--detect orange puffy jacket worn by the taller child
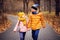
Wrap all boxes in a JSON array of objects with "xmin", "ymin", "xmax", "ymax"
[{"xmin": 28, "ymin": 13, "xmax": 45, "ymax": 30}]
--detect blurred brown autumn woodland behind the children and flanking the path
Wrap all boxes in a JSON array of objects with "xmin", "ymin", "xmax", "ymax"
[{"xmin": 0, "ymin": 0, "xmax": 60, "ymax": 33}]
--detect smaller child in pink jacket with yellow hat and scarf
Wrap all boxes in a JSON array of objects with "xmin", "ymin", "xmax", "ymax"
[{"xmin": 14, "ymin": 12, "xmax": 27, "ymax": 40}]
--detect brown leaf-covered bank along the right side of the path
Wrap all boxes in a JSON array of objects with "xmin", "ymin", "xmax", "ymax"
[{"xmin": 44, "ymin": 12, "xmax": 60, "ymax": 34}]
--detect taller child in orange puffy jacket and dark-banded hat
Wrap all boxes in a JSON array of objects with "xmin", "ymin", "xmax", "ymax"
[{"xmin": 28, "ymin": 4, "xmax": 45, "ymax": 40}]
